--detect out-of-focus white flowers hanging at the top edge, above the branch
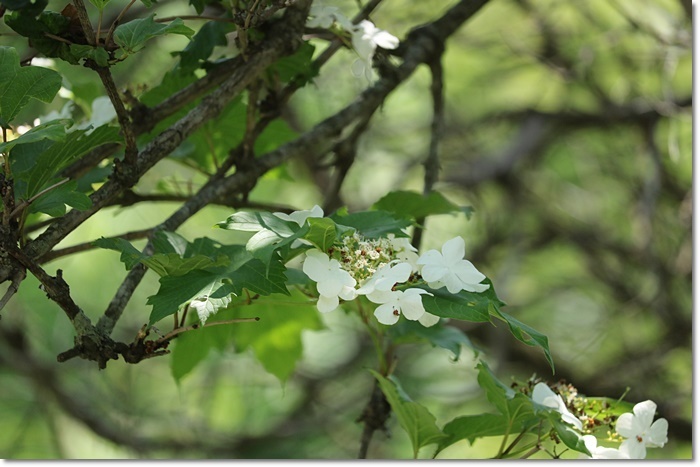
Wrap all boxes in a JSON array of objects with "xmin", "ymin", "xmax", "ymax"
[{"xmin": 306, "ymin": 0, "xmax": 399, "ymax": 81}]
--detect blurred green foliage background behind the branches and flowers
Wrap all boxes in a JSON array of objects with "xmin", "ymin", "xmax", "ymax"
[{"xmin": 0, "ymin": 0, "xmax": 692, "ymax": 459}]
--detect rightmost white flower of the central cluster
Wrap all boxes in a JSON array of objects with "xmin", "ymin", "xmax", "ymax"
[{"xmin": 417, "ymin": 237, "xmax": 489, "ymax": 293}]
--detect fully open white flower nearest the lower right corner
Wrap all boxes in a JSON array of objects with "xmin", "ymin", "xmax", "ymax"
[{"xmin": 615, "ymin": 401, "xmax": 668, "ymax": 459}]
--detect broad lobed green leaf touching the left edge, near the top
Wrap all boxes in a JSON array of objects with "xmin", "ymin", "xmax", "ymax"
[{"xmin": 0, "ymin": 46, "xmax": 62, "ymax": 124}]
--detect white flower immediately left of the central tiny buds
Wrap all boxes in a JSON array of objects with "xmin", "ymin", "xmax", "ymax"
[{"xmin": 302, "ymin": 250, "xmax": 357, "ymax": 313}]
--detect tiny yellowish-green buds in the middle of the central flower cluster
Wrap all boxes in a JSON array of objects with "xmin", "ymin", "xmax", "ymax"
[{"xmin": 328, "ymin": 233, "xmax": 394, "ymax": 283}]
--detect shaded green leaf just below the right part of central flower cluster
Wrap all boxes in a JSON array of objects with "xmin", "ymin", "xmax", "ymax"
[{"xmin": 389, "ymin": 320, "xmax": 480, "ymax": 361}]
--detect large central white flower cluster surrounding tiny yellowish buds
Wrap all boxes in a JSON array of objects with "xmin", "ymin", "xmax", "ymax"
[{"xmin": 275, "ymin": 206, "xmax": 489, "ymax": 326}]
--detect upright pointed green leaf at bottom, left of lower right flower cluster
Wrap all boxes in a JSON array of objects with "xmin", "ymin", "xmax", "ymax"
[{"xmin": 369, "ymin": 370, "xmax": 445, "ymax": 459}]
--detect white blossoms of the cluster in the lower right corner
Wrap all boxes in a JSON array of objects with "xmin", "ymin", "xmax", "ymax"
[{"xmin": 532, "ymin": 383, "xmax": 668, "ymax": 459}]
